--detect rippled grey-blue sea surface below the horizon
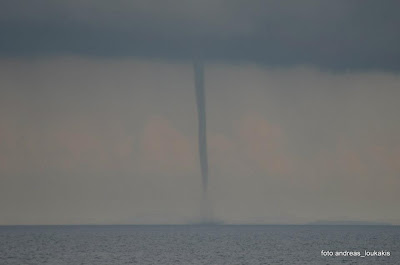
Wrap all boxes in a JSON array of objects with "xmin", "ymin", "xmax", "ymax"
[{"xmin": 0, "ymin": 225, "xmax": 400, "ymax": 265}]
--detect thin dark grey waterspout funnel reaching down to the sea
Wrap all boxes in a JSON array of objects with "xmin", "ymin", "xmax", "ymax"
[{"xmin": 193, "ymin": 61, "xmax": 210, "ymax": 221}]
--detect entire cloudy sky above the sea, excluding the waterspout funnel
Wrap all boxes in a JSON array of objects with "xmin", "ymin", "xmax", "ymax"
[{"xmin": 0, "ymin": 0, "xmax": 400, "ymax": 224}]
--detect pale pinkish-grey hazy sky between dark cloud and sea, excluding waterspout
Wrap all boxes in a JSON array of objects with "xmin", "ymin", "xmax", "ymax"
[{"xmin": 0, "ymin": 57, "xmax": 400, "ymax": 224}]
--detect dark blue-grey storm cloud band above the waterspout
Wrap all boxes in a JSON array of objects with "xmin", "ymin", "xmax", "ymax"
[{"xmin": 0, "ymin": 0, "xmax": 400, "ymax": 70}]
